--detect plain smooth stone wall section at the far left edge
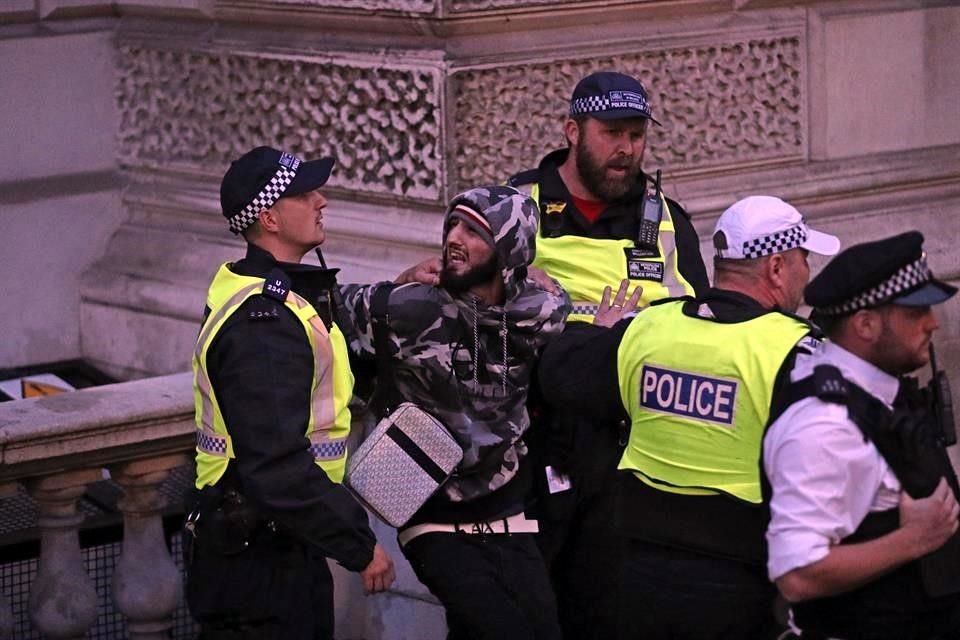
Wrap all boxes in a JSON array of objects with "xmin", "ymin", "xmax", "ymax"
[{"xmin": 0, "ymin": 26, "xmax": 124, "ymax": 368}]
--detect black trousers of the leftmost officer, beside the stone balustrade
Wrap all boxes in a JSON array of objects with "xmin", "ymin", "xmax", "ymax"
[{"xmin": 185, "ymin": 540, "xmax": 334, "ymax": 640}]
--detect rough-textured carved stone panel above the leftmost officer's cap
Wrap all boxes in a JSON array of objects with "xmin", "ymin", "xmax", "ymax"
[{"xmin": 117, "ymin": 43, "xmax": 443, "ymax": 200}]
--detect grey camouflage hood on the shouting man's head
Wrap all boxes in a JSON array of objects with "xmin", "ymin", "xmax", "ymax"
[{"xmin": 442, "ymin": 186, "xmax": 539, "ymax": 299}]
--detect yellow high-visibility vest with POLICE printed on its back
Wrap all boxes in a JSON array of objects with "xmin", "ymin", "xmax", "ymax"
[{"xmin": 617, "ymin": 301, "xmax": 809, "ymax": 504}]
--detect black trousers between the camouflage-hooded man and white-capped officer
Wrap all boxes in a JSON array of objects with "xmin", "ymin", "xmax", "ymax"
[{"xmin": 536, "ymin": 422, "xmax": 624, "ymax": 640}]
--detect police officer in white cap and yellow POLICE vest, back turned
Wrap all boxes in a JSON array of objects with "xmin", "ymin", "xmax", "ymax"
[{"xmin": 540, "ymin": 196, "xmax": 839, "ymax": 640}]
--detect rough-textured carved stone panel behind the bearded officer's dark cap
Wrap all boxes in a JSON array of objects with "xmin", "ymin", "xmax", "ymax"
[{"xmin": 453, "ymin": 35, "xmax": 806, "ymax": 188}]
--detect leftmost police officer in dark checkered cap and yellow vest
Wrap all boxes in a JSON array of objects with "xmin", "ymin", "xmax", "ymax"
[{"xmin": 187, "ymin": 147, "xmax": 394, "ymax": 640}]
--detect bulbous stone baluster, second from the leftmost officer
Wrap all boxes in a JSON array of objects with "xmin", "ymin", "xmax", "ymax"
[{"xmin": 26, "ymin": 469, "xmax": 101, "ymax": 639}]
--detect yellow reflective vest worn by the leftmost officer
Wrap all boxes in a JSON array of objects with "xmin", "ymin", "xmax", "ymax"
[{"xmin": 193, "ymin": 265, "xmax": 353, "ymax": 488}]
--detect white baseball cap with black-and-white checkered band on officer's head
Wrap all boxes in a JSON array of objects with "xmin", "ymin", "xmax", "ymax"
[{"xmin": 713, "ymin": 196, "xmax": 840, "ymax": 260}]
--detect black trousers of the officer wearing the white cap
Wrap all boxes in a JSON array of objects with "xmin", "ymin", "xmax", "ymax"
[{"xmin": 617, "ymin": 540, "xmax": 779, "ymax": 640}]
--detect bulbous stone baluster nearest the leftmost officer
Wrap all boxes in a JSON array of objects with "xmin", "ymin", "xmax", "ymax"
[{"xmin": 110, "ymin": 454, "xmax": 187, "ymax": 640}]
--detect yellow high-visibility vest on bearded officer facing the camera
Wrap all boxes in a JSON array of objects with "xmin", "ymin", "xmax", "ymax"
[{"xmin": 530, "ymin": 184, "xmax": 694, "ymax": 322}]
